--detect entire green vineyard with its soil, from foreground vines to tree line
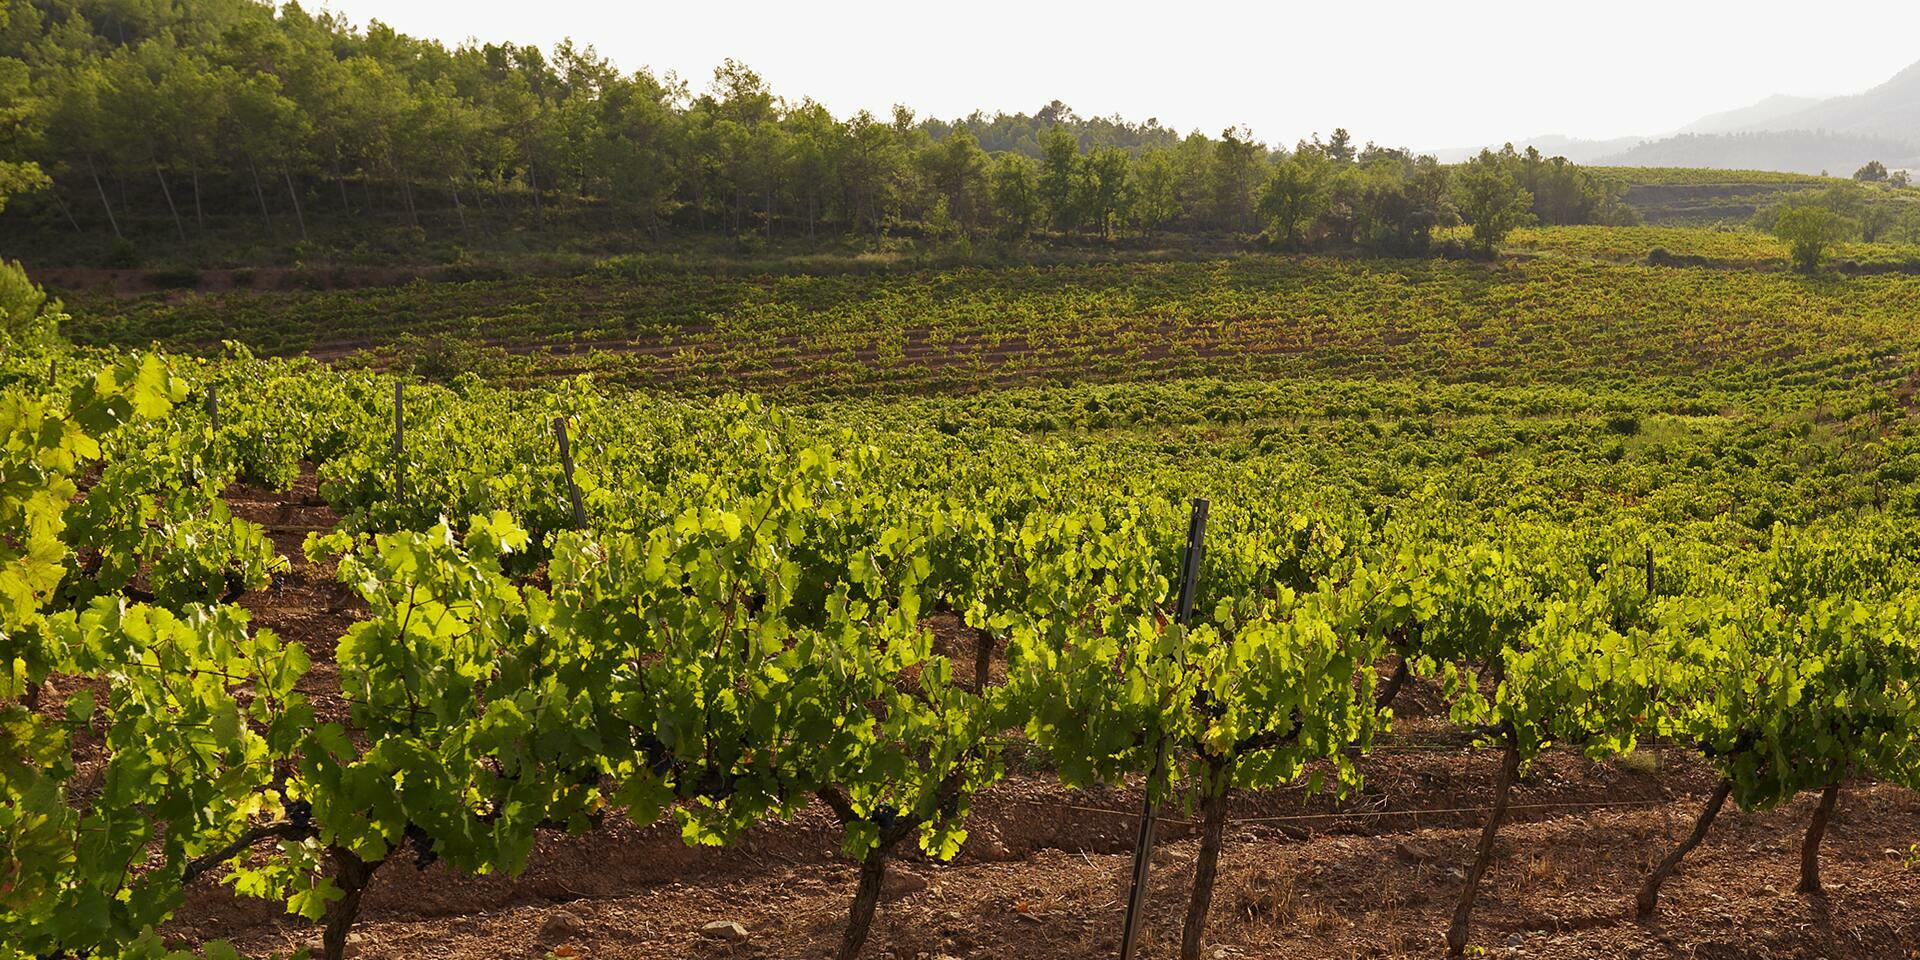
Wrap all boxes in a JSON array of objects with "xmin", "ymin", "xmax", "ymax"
[{"xmin": 11, "ymin": 228, "xmax": 1920, "ymax": 960}]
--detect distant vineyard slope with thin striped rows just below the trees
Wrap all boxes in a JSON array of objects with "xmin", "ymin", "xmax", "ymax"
[{"xmin": 52, "ymin": 251, "xmax": 1920, "ymax": 399}]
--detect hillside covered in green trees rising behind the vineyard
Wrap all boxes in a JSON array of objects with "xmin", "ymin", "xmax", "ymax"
[{"xmin": 0, "ymin": 0, "xmax": 1626, "ymax": 265}]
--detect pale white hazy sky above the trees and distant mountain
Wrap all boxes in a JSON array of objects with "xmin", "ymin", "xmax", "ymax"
[{"xmin": 326, "ymin": 0, "xmax": 1920, "ymax": 148}]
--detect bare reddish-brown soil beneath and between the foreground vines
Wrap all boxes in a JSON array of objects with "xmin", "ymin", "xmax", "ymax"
[{"xmin": 157, "ymin": 483, "xmax": 1920, "ymax": 960}]
